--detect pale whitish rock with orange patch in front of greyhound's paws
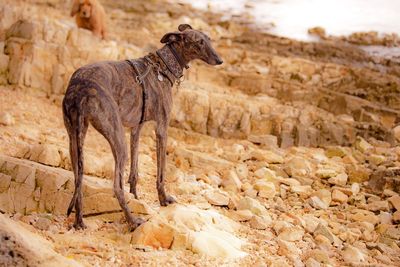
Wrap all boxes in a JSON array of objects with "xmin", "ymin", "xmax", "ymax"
[{"xmin": 131, "ymin": 205, "xmax": 246, "ymax": 258}]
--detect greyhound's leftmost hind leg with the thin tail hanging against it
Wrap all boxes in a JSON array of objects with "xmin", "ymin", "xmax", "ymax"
[{"xmin": 64, "ymin": 105, "xmax": 88, "ymax": 229}]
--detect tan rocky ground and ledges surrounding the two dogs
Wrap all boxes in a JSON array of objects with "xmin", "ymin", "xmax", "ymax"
[{"xmin": 0, "ymin": 0, "xmax": 400, "ymax": 267}]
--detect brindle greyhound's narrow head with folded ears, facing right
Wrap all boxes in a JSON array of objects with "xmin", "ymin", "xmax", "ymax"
[{"xmin": 161, "ymin": 24, "xmax": 223, "ymax": 65}]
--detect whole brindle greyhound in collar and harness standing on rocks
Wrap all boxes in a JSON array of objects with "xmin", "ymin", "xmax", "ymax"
[{"xmin": 63, "ymin": 24, "xmax": 223, "ymax": 230}]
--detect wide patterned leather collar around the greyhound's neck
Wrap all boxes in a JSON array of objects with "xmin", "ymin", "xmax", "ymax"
[{"xmin": 156, "ymin": 44, "xmax": 189, "ymax": 79}]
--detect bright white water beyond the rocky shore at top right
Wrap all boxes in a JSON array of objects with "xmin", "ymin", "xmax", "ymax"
[{"xmin": 180, "ymin": 0, "xmax": 400, "ymax": 41}]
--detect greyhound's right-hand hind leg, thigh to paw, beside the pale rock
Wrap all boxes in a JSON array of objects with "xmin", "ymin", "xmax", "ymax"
[{"xmin": 90, "ymin": 98, "xmax": 144, "ymax": 230}]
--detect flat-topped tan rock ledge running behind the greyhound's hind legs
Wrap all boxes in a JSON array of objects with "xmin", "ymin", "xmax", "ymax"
[{"xmin": 0, "ymin": 156, "xmax": 154, "ymax": 215}]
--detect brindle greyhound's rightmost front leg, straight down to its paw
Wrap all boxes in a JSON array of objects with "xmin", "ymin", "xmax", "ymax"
[{"xmin": 156, "ymin": 122, "xmax": 176, "ymax": 206}]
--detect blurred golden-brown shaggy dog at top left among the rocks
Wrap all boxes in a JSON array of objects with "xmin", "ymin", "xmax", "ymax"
[{"xmin": 71, "ymin": 0, "xmax": 106, "ymax": 39}]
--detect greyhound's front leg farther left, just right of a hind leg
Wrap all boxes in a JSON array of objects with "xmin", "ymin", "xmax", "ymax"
[{"xmin": 129, "ymin": 124, "xmax": 143, "ymax": 199}]
